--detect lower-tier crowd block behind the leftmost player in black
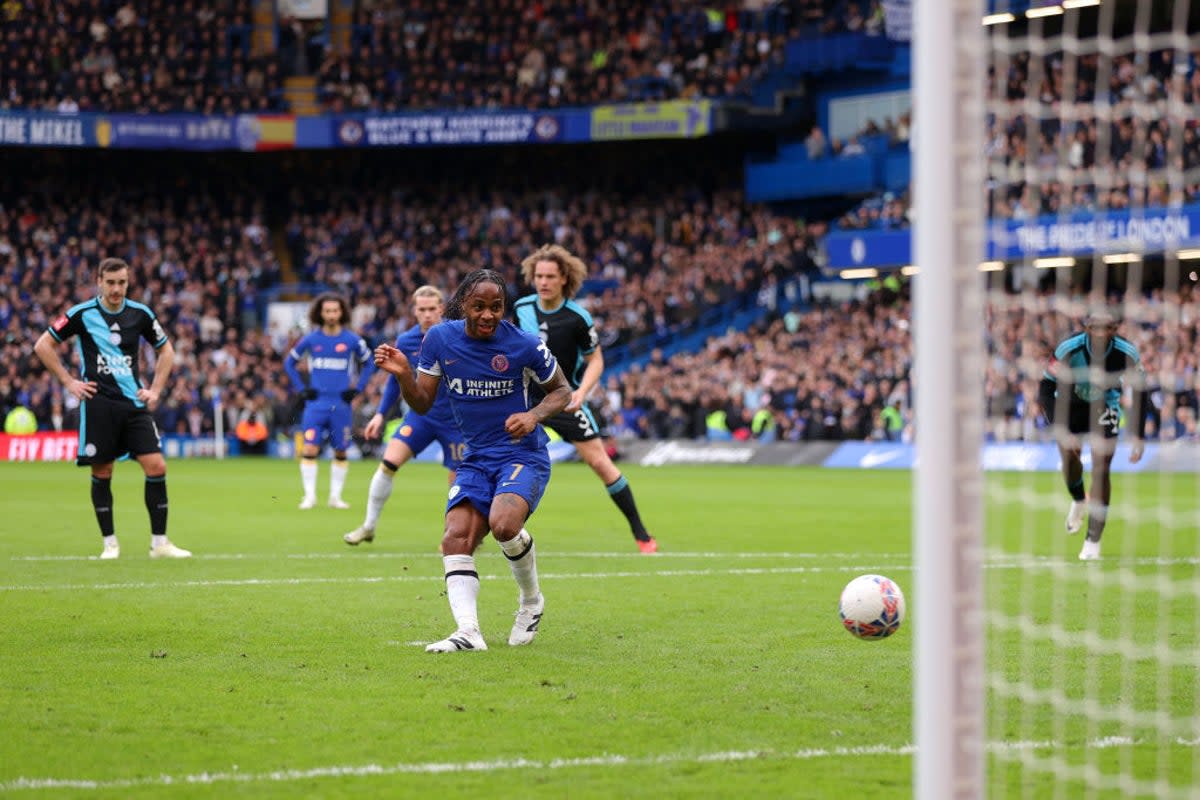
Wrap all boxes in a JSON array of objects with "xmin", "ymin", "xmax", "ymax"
[{"xmin": 0, "ymin": 152, "xmax": 286, "ymax": 434}]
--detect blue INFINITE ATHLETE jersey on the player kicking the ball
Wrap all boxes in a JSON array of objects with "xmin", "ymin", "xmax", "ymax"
[{"xmin": 416, "ymin": 319, "xmax": 558, "ymax": 461}]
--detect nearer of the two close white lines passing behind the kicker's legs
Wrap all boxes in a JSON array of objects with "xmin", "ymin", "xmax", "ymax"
[{"xmin": 0, "ymin": 557, "xmax": 1200, "ymax": 593}]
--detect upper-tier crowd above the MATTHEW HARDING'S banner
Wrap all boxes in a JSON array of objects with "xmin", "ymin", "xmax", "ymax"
[{"xmin": 0, "ymin": 0, "xmax": 902, "ymax": 114}]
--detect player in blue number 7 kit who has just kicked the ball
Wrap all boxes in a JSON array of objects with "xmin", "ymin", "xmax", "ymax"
[{"xmin": 374, "ymin": 270, "xmax": 571, "ymax": 652}]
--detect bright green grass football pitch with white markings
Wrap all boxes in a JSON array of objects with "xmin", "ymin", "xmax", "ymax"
[{"xmin": 0, "ymin": 459, "xmax": 1200, "ymax": 798}]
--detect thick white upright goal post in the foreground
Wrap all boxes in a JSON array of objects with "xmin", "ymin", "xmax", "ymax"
[{"xmin": 912, "ymin": 0, "xmax": 984, "ymax": 800}]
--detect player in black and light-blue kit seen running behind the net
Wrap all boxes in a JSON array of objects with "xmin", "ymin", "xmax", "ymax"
[{"xmin": 1038, "ymin": 309, "xmax": 1150, "ymax": 561}]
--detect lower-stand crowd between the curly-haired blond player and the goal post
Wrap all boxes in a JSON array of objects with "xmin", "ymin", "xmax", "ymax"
[{"xmin": 599, "ymin": 280, "xmax": 912, "ymax": 441}]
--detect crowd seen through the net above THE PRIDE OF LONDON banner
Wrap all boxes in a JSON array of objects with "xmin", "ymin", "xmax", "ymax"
[{"xmin": 986, "ymin": 49, "xmax": 1200, "ymax": 219}]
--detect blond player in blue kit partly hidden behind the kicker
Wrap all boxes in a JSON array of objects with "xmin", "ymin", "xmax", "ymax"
[{"xmin": 342, "ymin": 285, "xmax": 466, "ymax": 545}]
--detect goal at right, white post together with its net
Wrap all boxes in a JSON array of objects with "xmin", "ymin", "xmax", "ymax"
[{"xmin": 913, "ymin": 0, "xmax": 1200, "ymax": 798}]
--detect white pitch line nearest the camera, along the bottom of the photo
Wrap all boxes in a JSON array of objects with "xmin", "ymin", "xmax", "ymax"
[{"xmin": 0, "ymin": 736, "xmax": 1196, "ymax": 793}]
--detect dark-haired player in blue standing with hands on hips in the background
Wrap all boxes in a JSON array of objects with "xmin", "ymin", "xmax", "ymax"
[{"xmin": 283, "ymin": 294, "xmax": 374, "ymax": 510}]
